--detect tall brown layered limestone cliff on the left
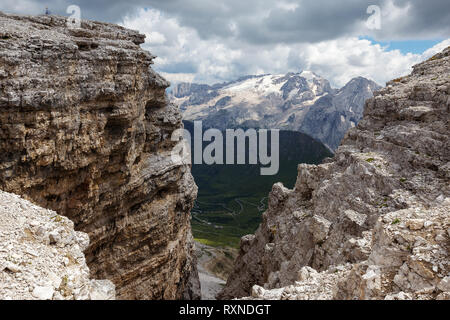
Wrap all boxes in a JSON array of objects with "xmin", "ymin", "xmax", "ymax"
[{"xmin": 0, "ymin": 14, "xmax": 199, "ymax": 299}]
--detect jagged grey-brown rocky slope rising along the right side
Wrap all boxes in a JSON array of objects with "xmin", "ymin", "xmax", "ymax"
[{"xmin": 220, "ymin": 48, "xmax": 450, "ymax": 299}]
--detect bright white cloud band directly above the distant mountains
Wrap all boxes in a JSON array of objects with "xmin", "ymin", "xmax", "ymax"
[{"xmin": 122, "ymin": 7, "xmax": 450, "ymax": 87}]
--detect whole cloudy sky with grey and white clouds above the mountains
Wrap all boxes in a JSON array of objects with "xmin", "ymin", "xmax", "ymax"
[{"xmin": 0, "ymin": 0, "xmax": 450, "ymax": 87}]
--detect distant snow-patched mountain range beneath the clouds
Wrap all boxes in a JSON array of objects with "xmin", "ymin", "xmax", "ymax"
[{"xmin": 169, "ymin": 71, "xmax": 381, "ymax": 151}]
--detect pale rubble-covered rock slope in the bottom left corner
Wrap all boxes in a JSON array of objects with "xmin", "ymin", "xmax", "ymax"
[{"xmin": 0, "ymin": 191, "xmax": 115, "ymax": 300}]
